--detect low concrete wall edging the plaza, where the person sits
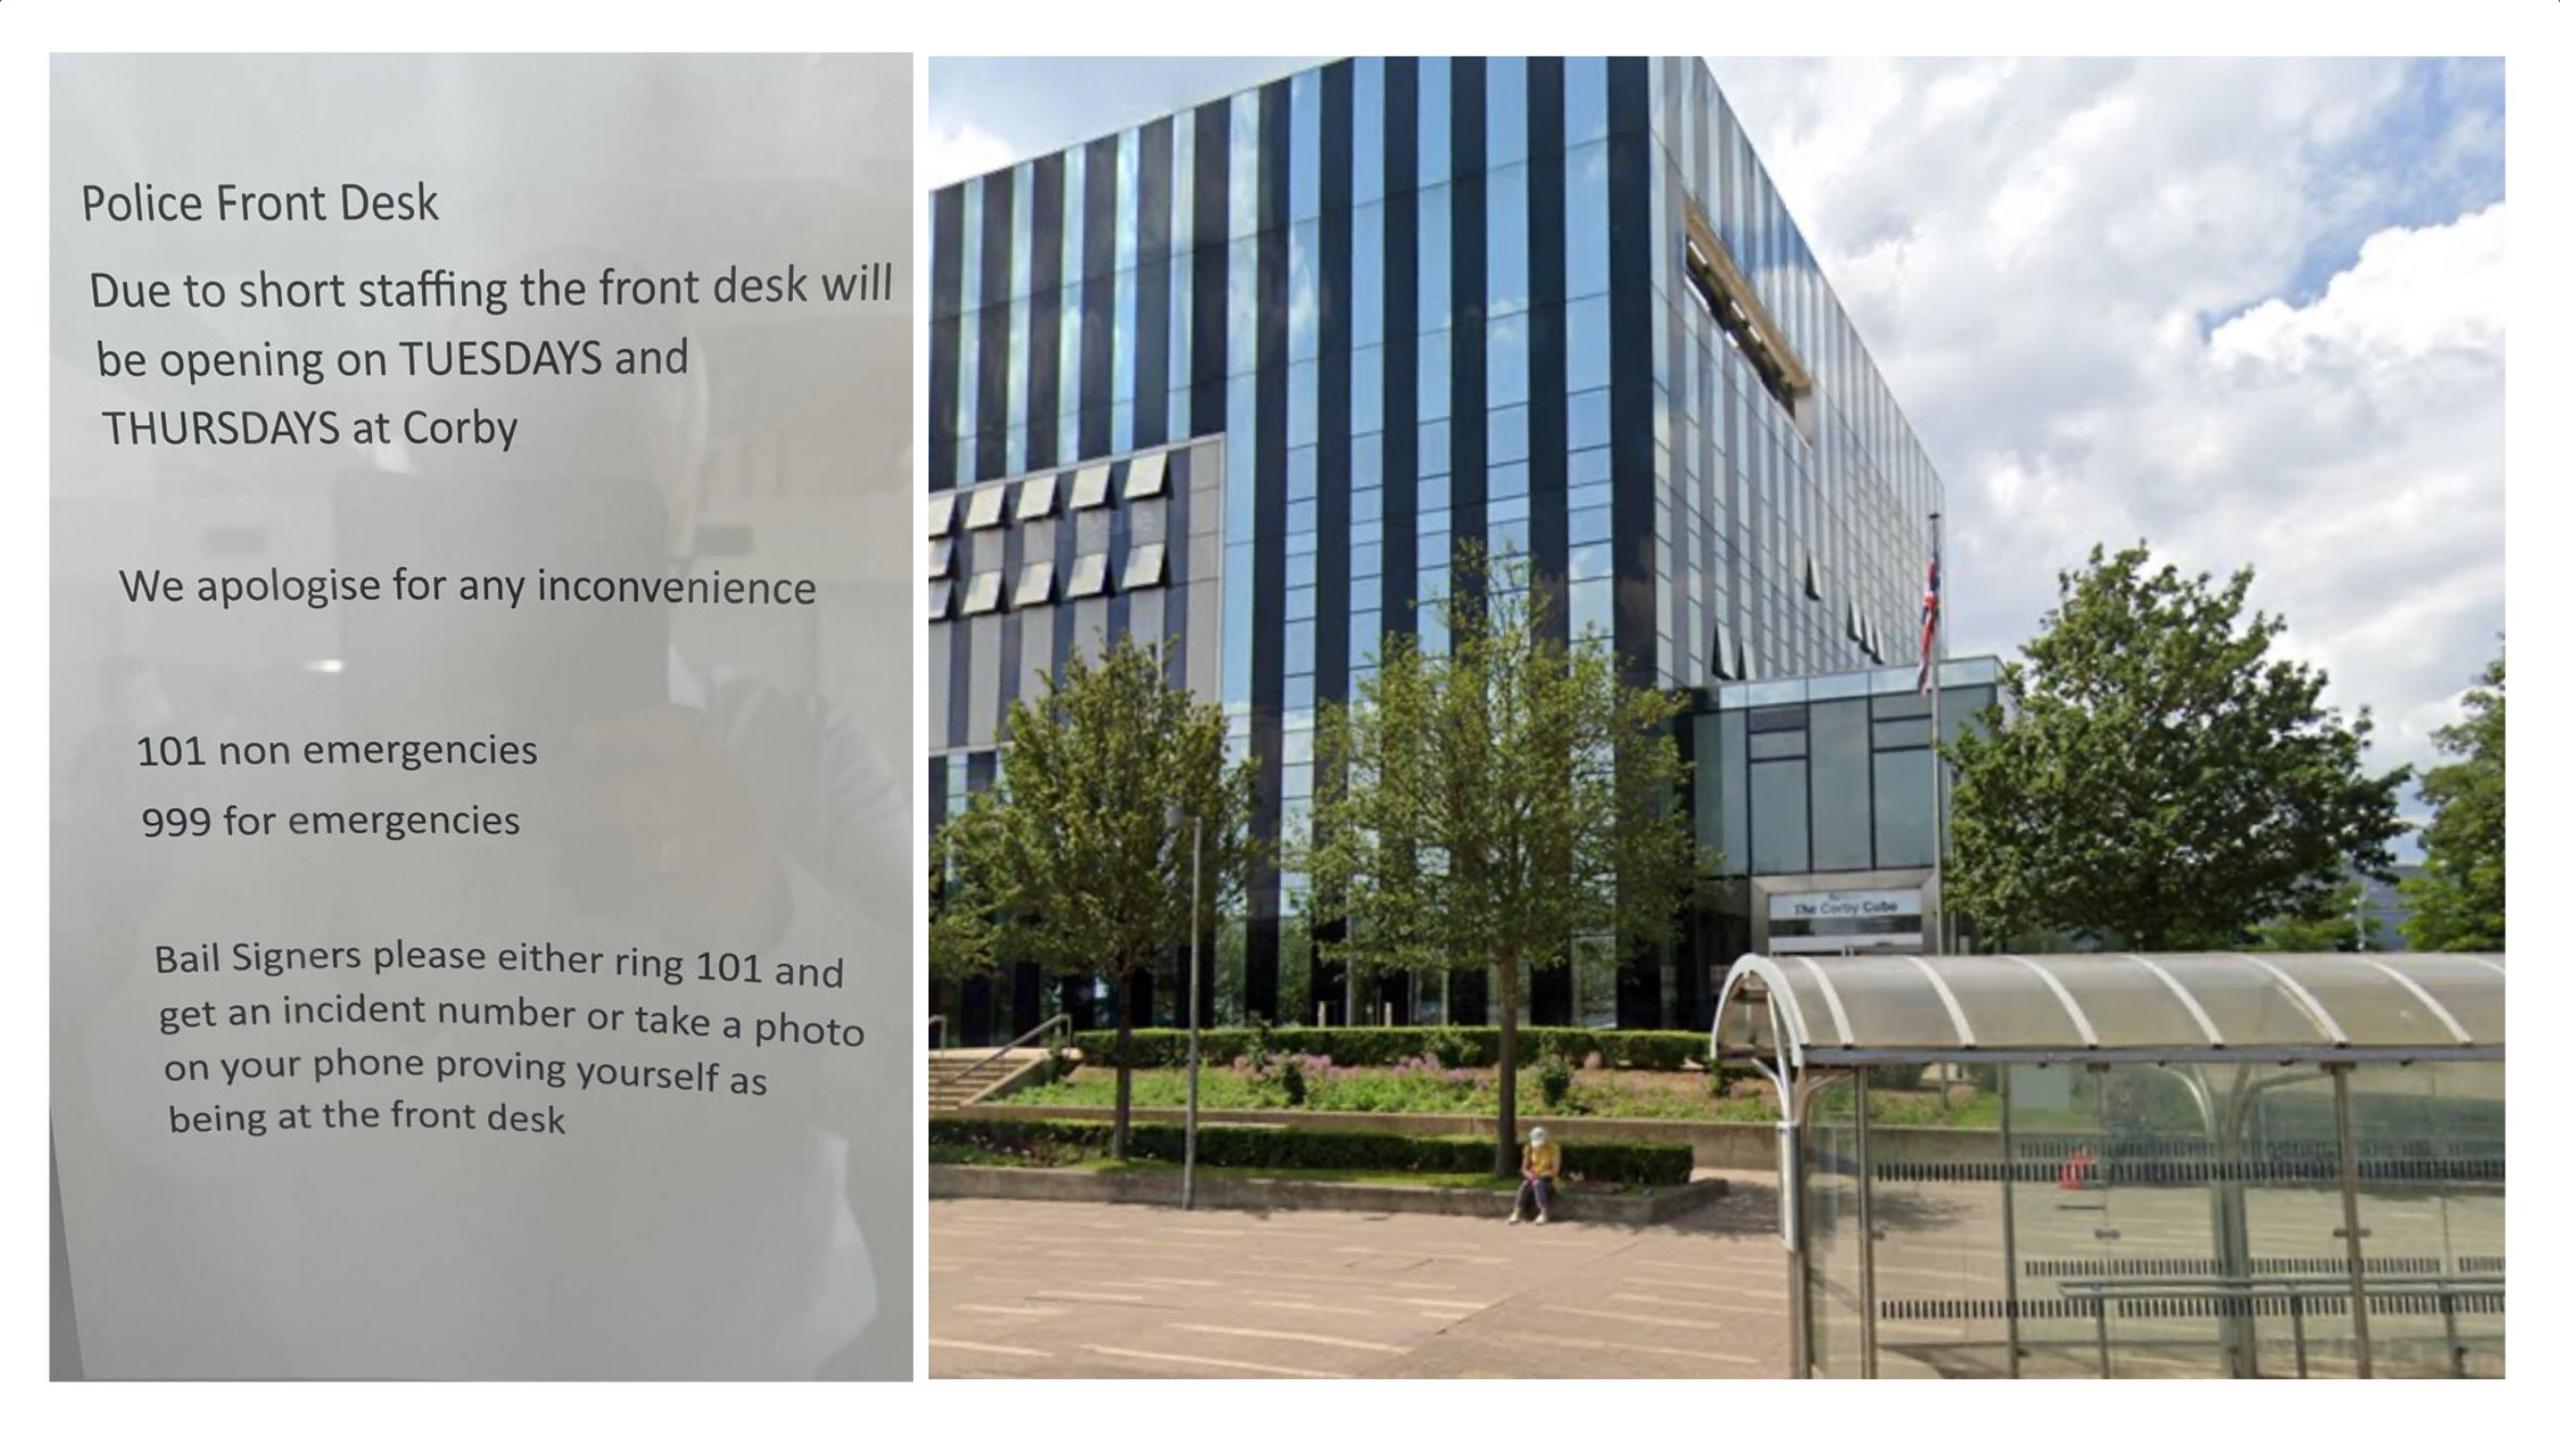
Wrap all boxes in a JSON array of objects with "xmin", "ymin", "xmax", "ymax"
[{"xmin": 927, "ymin": 1165, "xmax": 1725, "ymax": 1227}]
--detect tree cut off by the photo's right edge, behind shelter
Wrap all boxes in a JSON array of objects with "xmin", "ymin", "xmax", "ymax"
[{"xmin": 2401, "ymin": 656, "xmax": 2506, "ymax": 953}]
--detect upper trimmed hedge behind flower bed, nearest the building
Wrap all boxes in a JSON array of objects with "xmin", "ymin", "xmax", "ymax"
[{"xmin": 1075, "ymin": 1027, "xmax": 1713, "ymax": 1070}]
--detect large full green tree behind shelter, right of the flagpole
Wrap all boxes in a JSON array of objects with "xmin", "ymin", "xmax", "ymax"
[{"xmin": 1948, "ymin": 545, "xmax": 2409, "ymax": 950}]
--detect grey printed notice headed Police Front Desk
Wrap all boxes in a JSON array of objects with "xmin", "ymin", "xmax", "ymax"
[{"xmin": 49, "ymin": 56, "xmax": 914, "ymax": 1378}]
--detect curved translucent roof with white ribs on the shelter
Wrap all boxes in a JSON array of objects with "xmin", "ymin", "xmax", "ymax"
[{"xmin": 1715, "ymin": 953, "xmax": 2506, "ymax": 1065}]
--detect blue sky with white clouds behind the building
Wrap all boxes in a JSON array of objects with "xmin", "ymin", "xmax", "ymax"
[{"xmin": 924, "ymin": 56, "xmax": 2506, "ymax": 829}]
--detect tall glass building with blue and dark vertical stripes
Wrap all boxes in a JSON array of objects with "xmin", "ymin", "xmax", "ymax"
[{"xmin": 927, "ymin": 59, "xmax": 1940, "ymax": 1040}]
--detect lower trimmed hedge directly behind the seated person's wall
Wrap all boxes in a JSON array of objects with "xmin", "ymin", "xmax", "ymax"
[{"xmin": 929, "ymin": 1117, "xmax": 1692, "ymax": 1186}]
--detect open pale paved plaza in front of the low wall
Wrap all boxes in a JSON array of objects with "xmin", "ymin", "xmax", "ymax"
[{"xmin": 929, "ymin": 1173, "xmax": 1787, "ymax": 1378}]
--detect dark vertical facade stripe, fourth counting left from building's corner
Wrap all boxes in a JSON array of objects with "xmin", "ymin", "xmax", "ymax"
[{"xmin": 1377, "ymin": 59, "xmax": 1421, "ymax": 635}]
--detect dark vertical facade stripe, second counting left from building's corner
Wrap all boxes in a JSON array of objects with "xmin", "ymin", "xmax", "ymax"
[{"xmin": 1528, "ymin": 59, "xmax": 1574, "ymax": 1027}]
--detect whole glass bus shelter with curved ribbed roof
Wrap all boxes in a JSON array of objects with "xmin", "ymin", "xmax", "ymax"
[{"xmin": 1715, "ymin": 953, "xmax": 2506, "ymax": 1378}]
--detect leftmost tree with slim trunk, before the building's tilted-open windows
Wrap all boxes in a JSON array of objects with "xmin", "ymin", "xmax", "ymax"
[{"xmin": 932, "ymin": 640, "xmax": 1252, "ymax": 1158}]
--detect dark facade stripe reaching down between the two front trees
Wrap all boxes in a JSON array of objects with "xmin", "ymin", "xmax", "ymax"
[{"xmin": 1244, "ymin": 79, "xmax": 1288, "ymax": 1022}]
